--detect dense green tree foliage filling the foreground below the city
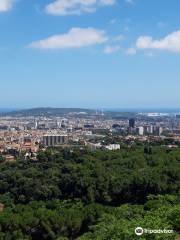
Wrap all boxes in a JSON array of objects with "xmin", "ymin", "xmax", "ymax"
[{"xmin": 0, "ymin": 146, "xmax": 180, "ymax": 240}]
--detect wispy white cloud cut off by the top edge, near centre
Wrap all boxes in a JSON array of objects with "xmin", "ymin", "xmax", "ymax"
[{"xmin": 45, "ymin": 0, "xmax": 116, "ymax": 16}]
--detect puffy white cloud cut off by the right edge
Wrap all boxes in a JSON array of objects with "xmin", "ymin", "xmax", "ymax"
[{"xmin": 136, "ymin": 30, "xmax": 180, "ymax": 53}]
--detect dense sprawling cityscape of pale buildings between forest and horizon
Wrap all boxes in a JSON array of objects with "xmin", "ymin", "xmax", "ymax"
[{"xmin": 0, "ymin": 109, "xmax": 180, "ymax": 161}]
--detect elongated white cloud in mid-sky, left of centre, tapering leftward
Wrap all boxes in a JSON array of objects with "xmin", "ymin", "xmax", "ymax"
[{"xmin": 29, "ymin": 28, "xmax": 108, "ymax": 49}]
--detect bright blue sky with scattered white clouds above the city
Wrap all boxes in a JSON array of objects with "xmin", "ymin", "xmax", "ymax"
[{"xmin": 0, "ymin": 0, "xmax": 180, "ymax": 108}]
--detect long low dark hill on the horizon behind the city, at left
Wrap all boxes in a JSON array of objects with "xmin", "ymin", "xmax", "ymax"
[{"xmin": 1, "ymin": 107, "xmax": 95, "ymax": 117}]
